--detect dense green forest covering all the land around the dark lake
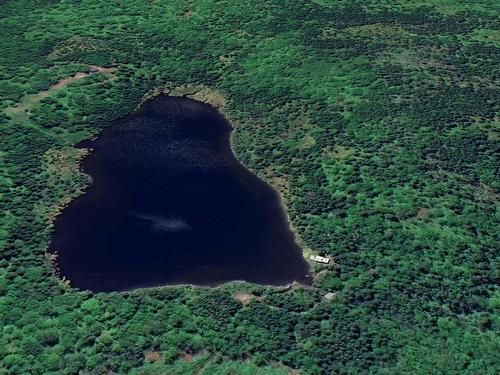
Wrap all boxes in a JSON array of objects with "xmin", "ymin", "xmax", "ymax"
[{"xmin": 0, "ymin": 0, "xmax": 500, "ymax": 375}]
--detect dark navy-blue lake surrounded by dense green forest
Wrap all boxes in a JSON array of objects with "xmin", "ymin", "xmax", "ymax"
[{"xmin": 50, "ymin": 95, "xmax": 312, "ymax": 291}]
